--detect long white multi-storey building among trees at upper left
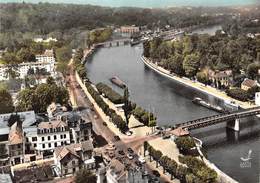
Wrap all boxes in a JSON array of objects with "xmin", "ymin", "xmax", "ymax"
[{"xmin": 0, "ymin": 50, "xmax": 55, "ymax": 80}]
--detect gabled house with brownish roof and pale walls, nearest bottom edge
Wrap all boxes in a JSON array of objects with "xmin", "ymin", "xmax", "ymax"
[{"xmin": 54, "ymin": 140, "xmax": 95, "ymax": 176}]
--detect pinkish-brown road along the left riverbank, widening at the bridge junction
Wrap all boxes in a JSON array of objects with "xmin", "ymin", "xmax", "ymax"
[{"xmin": 67, "ymin": 64, "xmax": 175, "ymax": 182}]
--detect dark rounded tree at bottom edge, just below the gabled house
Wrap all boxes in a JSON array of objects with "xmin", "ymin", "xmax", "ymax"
[{"xmin": 75, "ymin": 168, "xmax": 97, "ymax": 183}]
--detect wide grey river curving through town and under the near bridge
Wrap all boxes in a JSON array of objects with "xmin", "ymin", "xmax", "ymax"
[{"xmin": 86, "ymin": 41, "xmax": 260, "ymax": 183}]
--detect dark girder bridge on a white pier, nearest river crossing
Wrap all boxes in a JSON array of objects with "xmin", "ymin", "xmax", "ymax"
[{"xmin": 175, "ymin": 107, "xmax": 260, "ymax": 131}]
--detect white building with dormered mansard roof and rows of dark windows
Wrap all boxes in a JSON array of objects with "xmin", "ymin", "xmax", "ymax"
[{"xmin": 26, "ymin": 121, "xmax": 70, "ymax": 152}]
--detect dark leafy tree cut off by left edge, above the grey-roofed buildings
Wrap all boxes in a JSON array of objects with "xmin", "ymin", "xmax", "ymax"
[{"xmin": 0, "ymin": 89, "xmax": 14, "ymax": 114}]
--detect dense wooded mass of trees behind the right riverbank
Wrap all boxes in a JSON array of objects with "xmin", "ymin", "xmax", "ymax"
[{"xmin": 144, "ymin": 31, "xmax": 260, "ymax": 79}]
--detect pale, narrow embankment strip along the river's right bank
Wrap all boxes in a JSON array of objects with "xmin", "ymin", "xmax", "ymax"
[{"xmin": 141, "ymin": 56, "xmax": 256, "ymax": 109}]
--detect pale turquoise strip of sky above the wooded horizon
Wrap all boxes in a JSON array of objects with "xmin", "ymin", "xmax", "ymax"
[{"xmin": 0, "ymin": 0, "xmax": 260, "ymax": 8}]
